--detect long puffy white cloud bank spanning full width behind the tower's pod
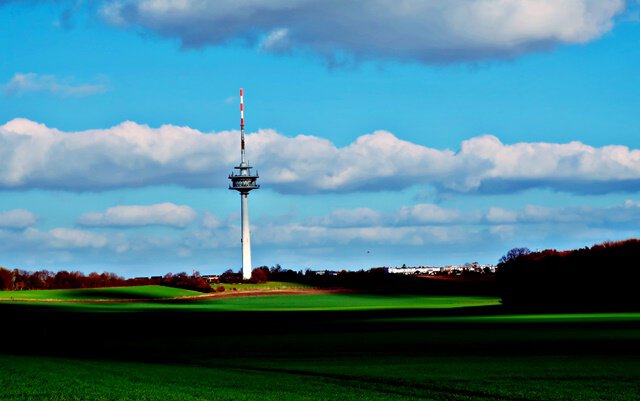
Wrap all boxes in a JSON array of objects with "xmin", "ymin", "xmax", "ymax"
[{"xmin": 0, "ymin": 119, "xmax": 640, "ymax": 195}]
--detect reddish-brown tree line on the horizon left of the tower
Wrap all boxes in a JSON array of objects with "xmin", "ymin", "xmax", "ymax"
[{"xmin": 0, "ymin": 267, "xmax": 211, "ymax": 292}]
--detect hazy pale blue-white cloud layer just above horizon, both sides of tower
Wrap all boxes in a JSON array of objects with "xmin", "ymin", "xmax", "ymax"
[{"xmin": 0, "ymin": 199, "xmax": 640, "ymax": 274}]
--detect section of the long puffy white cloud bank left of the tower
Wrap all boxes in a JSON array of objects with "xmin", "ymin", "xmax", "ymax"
[{"xmin": 0, "ymin": 119, "xmax": 239, "ymax": 190}]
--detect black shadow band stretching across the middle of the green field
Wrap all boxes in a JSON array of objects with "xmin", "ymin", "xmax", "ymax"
[{"xmin": 0, "ymin": 304, "xmax": 640, "ymax": 363}]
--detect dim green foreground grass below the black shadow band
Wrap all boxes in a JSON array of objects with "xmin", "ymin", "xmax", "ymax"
[{"xmin": 0, "ymin": 355, "xmax": 640, "ymax": 401}]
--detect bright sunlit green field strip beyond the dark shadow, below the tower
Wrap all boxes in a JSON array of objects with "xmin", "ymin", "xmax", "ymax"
[{"xmin": 0, "ymin": 283, "xmax": 500, "ymax": 311}]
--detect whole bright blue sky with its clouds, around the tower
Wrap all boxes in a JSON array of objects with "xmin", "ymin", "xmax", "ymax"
[{"xmin": 0, "ymin": 0, "xmax": 640, "ymax": 276}]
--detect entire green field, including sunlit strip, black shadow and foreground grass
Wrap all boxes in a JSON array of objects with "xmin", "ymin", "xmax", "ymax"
[{"xmin": 0, "ymin": 282, "xmax": 640, "ymax": 401}]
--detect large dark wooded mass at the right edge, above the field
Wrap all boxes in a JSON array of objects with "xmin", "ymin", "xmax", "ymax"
[{"xmin": 496, "ymin": 239, "xmax": 640, "ymax": 310}]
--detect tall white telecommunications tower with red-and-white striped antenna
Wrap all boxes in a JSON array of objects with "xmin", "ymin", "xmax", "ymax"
[{"xmin": 229, "ymin": 88, "xmax": 260, "ymax": 280}]
